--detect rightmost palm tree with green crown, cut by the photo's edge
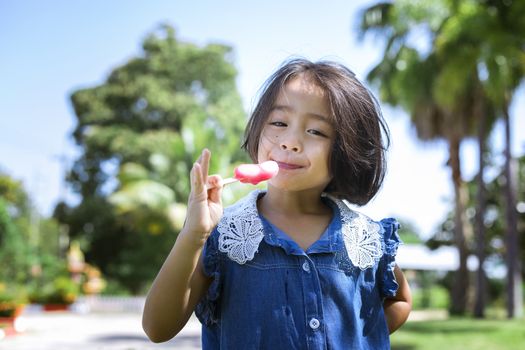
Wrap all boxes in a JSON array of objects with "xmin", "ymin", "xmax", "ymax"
[{"xmin": 480, "ymin": 0, "xmax": 525, "ymax": 318}]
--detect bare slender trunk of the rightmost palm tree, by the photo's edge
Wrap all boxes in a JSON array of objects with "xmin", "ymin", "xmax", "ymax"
[{"xmin": 503, "ymin": 106, "xmax": 523, "ymax": 318}]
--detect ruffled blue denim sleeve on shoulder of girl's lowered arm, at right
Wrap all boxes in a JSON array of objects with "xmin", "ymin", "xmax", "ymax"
[{"xmin": 380, "ymin": 218, "xmax": 402, "ymax": 298}]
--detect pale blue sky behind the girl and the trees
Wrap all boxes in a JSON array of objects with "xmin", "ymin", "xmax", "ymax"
[{"xmin": 0, "ymin": 0, "xmax": 525, "ymax": 236}]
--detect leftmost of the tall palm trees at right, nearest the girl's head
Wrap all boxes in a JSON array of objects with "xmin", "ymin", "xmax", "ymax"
[{"xmin": 354, "ymin": 2, "xmax": 494, "ymax": 314}]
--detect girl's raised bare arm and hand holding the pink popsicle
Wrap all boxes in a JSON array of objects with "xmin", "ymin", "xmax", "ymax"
[{"xmin": 142, "ymin": 150, "xmax": 223, "ymax": 343}]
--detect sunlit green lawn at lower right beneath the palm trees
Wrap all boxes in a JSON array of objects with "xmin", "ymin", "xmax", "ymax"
[{"xmin": 390, "ymin": 318, "xmax": 525, "ymax": 350}]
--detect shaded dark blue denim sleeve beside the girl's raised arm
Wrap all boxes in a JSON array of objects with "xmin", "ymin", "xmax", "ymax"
[{"xmin": 195, "ymin": 230, "xmax": 221, "ymax": 326}]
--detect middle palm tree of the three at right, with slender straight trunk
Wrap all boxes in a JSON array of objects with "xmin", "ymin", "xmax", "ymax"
[{"xmin": 428, "ymin": 4, "xmax": 495, "ymax": 318}]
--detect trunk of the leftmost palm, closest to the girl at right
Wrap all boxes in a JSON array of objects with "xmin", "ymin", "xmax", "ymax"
[{"xmin": 449, "ymin": 137, "xmax": 469, "ymax": 315}]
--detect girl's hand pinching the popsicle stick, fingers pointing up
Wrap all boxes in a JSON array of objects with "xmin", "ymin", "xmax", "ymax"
[{"xmin": 184, "ymin": 149, "xmax": 223, "ymax": 244}]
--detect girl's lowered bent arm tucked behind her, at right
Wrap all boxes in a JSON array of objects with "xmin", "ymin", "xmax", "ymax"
[{"xmin": 383, "ymin": 265, "xmax": 412, "ymax": 334}]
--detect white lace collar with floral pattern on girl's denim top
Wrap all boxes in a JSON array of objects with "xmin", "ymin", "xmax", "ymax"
[{"xmin": 217, "ymin": 190, "xmax": 383, "ymax": 270}]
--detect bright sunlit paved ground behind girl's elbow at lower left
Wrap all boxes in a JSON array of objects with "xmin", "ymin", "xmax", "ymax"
[{"xmin": 0, "ymin": 312, "xmax": 201, "ymax": 350}]
